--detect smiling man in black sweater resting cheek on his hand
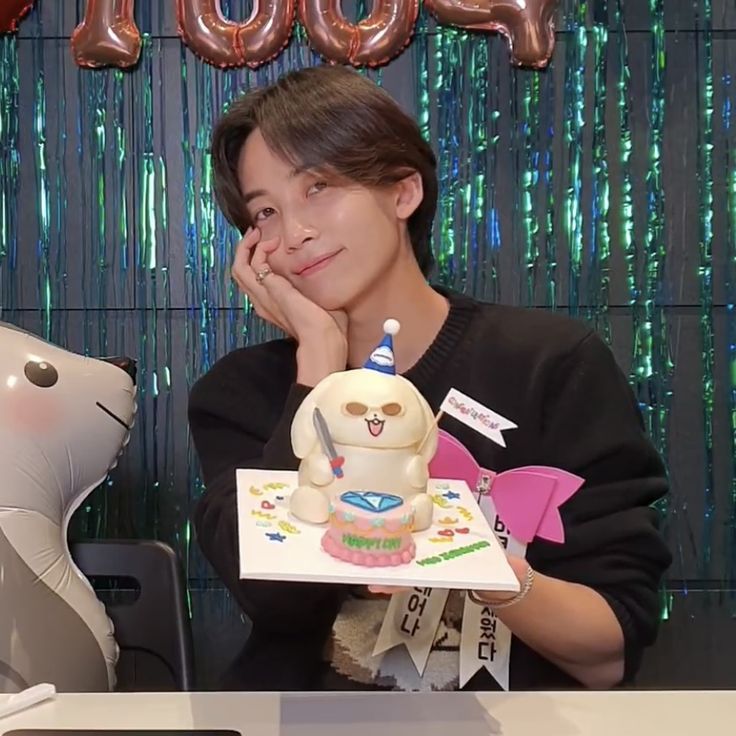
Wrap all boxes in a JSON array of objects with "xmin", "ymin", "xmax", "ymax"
[{"xmin": 189, "ymin": 67, "xmax": 670, "ymax": 690}]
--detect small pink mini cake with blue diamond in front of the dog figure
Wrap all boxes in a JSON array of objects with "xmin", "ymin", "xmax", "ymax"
[{"xmin": 322, "ymin": 491, "xmax": 416, "ymax": 567}]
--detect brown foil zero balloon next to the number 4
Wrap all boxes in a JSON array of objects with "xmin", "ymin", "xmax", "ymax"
[{"xmin": 299, "ymin": 0, "xmax": 419, "ymax": 66}]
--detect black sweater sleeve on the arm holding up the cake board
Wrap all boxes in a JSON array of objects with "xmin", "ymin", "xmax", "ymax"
[{"xmin": 529, "ymin": 333, "xmax": 671, "ymax": 681}]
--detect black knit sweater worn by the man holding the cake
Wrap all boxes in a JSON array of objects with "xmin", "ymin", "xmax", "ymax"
[{"xmin": 189, "ymin": 294, "xmax": 670, "ymax": 690}]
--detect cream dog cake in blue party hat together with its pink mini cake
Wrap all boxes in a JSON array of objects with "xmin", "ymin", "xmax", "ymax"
[{"xmin": 289, "ymin": 320, "xmax": 438, "ymax": 567}]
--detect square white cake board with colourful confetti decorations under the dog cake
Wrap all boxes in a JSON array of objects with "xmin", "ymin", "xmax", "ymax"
[{"xmin": 237, "ymin": 469, "xmax": 519, "ymax": 591}]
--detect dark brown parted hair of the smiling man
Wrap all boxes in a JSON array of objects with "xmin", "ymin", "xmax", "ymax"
[{"xmin": 212, "ymin": 66, "xmax": 437, "ymax": 276}]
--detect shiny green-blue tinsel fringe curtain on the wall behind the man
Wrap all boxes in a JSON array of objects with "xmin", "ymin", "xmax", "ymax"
[{"xmin": 0, "ymin": 0, "xmax": 736, "ymax": 613}]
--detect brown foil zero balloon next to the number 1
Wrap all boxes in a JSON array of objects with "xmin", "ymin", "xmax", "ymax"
[{"xmin": 176, "ymin": 0, "xmax": 295, "ymax": 69}]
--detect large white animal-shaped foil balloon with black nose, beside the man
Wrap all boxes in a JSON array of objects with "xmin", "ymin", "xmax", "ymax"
[{"xmin": 0, "ymin": 322, "xmax": 136, "ymax": 692}]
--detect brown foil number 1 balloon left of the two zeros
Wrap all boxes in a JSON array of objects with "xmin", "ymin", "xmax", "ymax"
[{"xmin": 72, "ymin": 0, "xmax": 141, "ymax": 69}]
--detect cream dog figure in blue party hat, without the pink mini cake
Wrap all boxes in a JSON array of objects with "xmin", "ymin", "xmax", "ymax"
[{"xmin": 290, "ymin": 320, "xmax": 438, "ymax": 531}]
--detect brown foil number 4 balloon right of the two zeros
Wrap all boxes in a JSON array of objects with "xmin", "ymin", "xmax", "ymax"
[{"xmin": 424, "ymin": 0, "xmax": 557, "ymax": 69}]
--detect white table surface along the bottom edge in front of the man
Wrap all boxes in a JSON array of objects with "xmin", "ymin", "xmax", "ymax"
[{"xmin": 0, "ymin": 691, "xmax": 736, "ymax": 736}]
